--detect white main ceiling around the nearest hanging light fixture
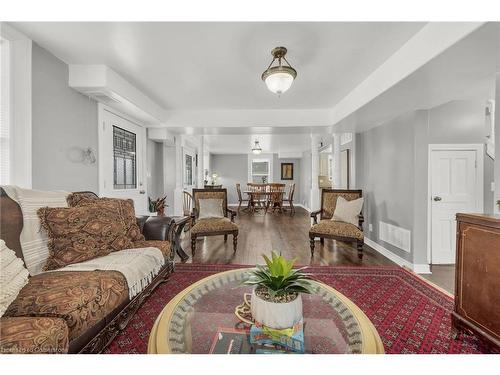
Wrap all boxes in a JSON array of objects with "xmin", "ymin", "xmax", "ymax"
[{"xmin": 13, "ymin": 22, "xmax": 425, "ymax": 110}]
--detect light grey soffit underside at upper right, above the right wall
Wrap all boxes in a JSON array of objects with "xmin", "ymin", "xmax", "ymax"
[{"xmin": 333, "ymin": 23, "xmax": 499, "ymax": 132}]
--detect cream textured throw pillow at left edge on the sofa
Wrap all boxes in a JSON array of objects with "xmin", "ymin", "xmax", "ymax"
[{"xmin": 0, "ymin": 240, "xmax": 29, "ymax": 317}]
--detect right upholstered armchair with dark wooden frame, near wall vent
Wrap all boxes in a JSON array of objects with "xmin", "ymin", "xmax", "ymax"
[{"xmin": 309, "ymin": 189, "xmax": 364, "ymax": 259}]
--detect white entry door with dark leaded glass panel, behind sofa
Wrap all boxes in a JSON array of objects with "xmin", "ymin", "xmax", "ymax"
[{"xmin": 99, "ymin": 107, "xmax": 149, "ymax": 215}]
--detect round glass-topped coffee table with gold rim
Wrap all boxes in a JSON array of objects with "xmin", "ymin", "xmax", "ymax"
[{"xmin": 148, "ymin": 269, "xmax": 384, "ymax": 354}]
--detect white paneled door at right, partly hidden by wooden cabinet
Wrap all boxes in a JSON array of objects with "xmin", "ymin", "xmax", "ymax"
[{"xmin": 430, "ymin": 149, "xmax": 482, "ymax": 264}]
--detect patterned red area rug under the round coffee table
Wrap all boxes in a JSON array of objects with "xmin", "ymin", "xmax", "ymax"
[{"xmin": 106, "ymin": 264, "xmax": 487, "ymax": 354}]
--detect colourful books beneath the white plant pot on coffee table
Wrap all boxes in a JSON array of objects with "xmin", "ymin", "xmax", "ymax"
[{"xmin": 250, "ymin": 320, "xmax": 305, "ymax": 354}]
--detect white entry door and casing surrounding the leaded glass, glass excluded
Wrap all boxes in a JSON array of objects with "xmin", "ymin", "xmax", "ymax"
[{"xmin": 98, "ymin": 104, "xmax": 149, "ymax": 215}]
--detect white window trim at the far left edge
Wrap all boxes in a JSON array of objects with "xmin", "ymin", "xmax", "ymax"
[{"xmin": 0, "ymin": 23, "xmax": 32, "ymax": 189}]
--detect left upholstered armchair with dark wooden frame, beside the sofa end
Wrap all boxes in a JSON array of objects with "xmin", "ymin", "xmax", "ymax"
[{"xmin": 191, "ymin": 189, "xmax": 238, "ymax": 256}]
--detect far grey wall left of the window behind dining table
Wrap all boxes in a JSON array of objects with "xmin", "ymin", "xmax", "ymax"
[{"xmin": 210, "ymin": 154, "xmax": 248, "ymax": 204}]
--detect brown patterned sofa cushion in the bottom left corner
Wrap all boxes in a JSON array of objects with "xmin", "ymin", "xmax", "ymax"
[{"xmin": 0, "ymin": 317, "xmax": 69, "ymax": 354}]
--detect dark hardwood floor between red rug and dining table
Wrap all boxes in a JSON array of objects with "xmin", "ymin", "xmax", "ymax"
[{"xmin": 182, "ymin": 207, "xmax": 395, "ymax": 266}]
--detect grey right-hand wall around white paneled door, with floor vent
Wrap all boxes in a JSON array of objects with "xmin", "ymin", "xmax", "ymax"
[{"xmin": 356, "ymin": 100, "xmax": 493, "ymax": 264}]
